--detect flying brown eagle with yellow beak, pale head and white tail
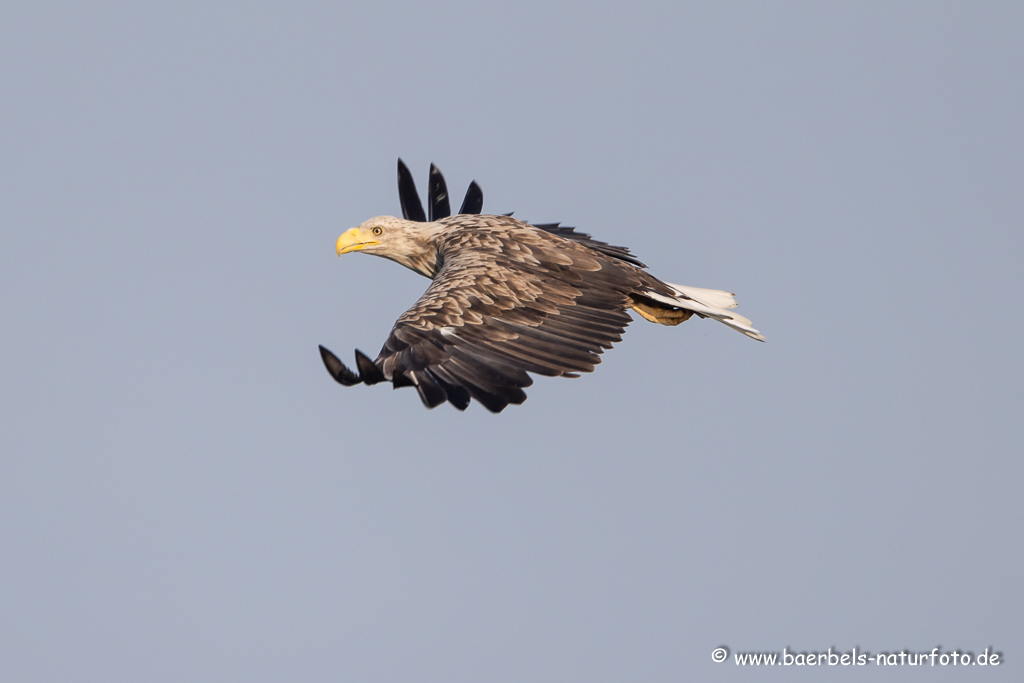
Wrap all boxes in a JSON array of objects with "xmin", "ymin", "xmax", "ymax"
[{"xmin": 319, "ymin": 159, "xmax": 765, "ymax": 413}]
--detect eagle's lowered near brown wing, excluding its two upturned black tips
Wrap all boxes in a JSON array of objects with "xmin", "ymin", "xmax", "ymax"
[{"xmin": 374, "ymin": 231, "xmax": 636, "ymax": 413}]
